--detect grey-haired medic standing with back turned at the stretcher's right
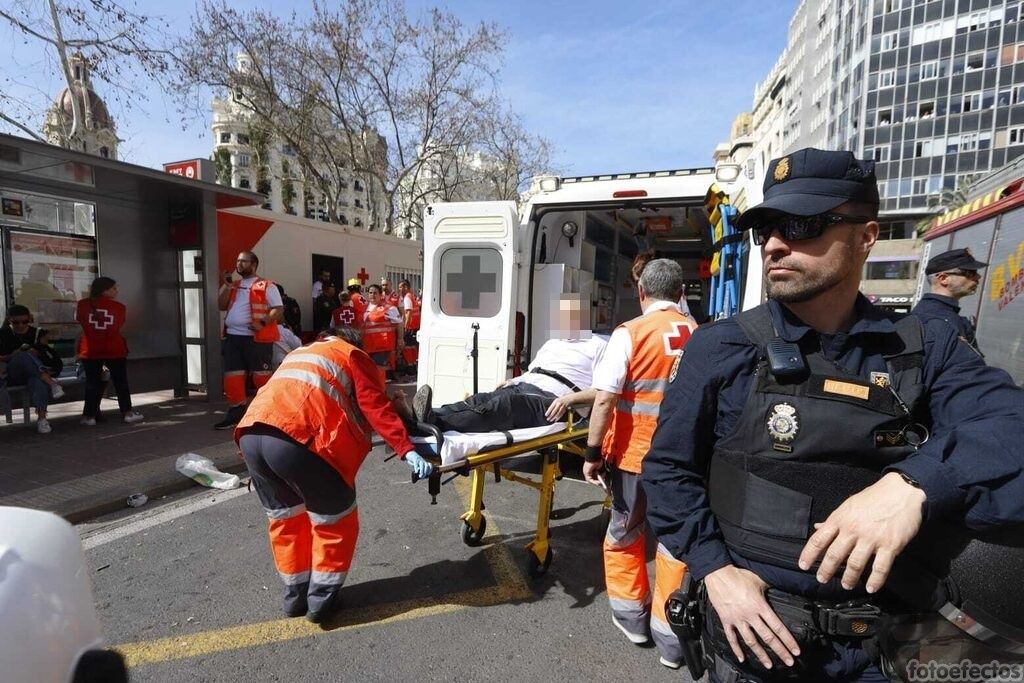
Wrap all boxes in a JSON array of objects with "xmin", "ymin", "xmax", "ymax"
[{"xmin": 584, "ymin": 258, "xmax": 696, "ymax": 669}]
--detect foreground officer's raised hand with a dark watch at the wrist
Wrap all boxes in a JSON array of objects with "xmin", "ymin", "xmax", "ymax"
[{"xmin": 800, "ymin": 472, "xmax": 925, "ymax": 593}]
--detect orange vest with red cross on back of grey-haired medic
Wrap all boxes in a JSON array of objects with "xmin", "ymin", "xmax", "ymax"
[{"xmin": 601, "ymin": 307, "xmax": 696, "ymax": 474}]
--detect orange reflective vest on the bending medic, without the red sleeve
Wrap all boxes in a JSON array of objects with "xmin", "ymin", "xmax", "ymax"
[{"xmin": 234, "ymin": 337, "xmax": 373, "ymax": 487}]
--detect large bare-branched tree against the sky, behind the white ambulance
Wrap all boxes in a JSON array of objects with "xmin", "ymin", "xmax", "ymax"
[{"xmin": 179, "ymin": 0, "xmax": 503, "ymax": 236}]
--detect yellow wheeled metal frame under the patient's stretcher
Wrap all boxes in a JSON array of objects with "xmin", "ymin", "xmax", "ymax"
[{"xmin": 421, "ymin": 415, "xmax": 598, "ymax": 579}]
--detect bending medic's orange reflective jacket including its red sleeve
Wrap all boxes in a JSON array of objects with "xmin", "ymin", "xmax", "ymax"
[{"xmin": 234, "ymin": 337, "xmax": 413, "ymax": 486}]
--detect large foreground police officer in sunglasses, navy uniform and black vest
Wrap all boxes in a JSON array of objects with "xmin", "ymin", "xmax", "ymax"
[{"xmin": 642, "ymin": 150, "xmax": 1024, "ymax": 681}]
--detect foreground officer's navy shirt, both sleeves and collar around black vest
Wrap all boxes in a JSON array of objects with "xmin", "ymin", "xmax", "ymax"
[{"xmin": 642, "ymin": 296, "xmax": 1024, "ymax": 590}]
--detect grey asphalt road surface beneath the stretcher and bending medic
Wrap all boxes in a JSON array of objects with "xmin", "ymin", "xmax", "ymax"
[{"xmin": 79, "ymin": 452, "xmax": 689, "ymax": 682}]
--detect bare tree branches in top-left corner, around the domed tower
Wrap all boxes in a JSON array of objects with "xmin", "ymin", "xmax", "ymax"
[{"xmin": 0, "ymin": 0, "xmax": 170, "ymax": 140}]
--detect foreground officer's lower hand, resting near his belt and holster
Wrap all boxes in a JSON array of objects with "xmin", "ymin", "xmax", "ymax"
[{"xmin": 705, "ymin": 565, "xmax": 800, "ymax": 669}]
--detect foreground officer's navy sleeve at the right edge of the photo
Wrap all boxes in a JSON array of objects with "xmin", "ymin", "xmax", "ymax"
[{"xmin": 891, "ymin": 319, "xmax": 1024, "ymax": 529}]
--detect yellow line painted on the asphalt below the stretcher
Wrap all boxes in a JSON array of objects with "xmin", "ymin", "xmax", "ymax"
[{"xmin": 114, "ymin": 478, "xmax": 532, "ymax": 668}]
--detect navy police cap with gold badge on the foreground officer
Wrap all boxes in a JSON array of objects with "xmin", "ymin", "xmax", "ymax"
[{"xmin": 737, "ymin": 147, "xmax": 879, "ymax": 230}]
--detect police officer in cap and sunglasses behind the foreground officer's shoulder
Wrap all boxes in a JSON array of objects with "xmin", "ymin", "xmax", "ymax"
[{"xmin": 910, "ymin": 249, "xmax": 988, "ymax": 353}]
